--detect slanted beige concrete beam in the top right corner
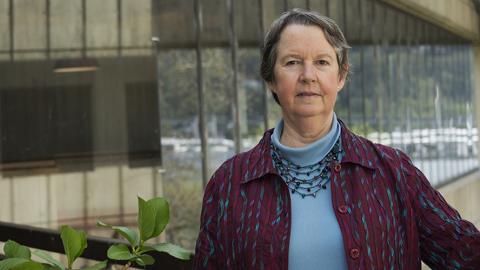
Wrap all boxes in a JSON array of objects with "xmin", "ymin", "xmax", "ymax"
[{"xmin": 380, "ymin": 0, "xmax": 480, "ymax": 43}]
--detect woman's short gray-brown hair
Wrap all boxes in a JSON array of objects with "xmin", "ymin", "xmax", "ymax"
[{"xmin": 260, "ymin": 8, "xmax": 350, "ymax": 104}]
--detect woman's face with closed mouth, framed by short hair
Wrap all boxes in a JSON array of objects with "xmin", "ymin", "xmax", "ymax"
[{"xmin": 268, "ymin": 24, "xmax": 345, "ymax": 118}]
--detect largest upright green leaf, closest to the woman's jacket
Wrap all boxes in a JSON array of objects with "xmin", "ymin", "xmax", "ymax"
[{"xmin": 138, "ymin": 197, "xmax": 169, "ymax": 241}]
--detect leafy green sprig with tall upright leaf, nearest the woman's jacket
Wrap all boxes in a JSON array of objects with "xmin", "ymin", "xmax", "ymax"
[{"xmin": 97, "ymin": 197, "xmax": 192, "ymax": 269}]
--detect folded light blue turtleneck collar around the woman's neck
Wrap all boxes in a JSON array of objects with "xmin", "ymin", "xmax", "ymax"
[{"xmin": 271, "ymin": 113, "xmax": 341, "ymax": 166}]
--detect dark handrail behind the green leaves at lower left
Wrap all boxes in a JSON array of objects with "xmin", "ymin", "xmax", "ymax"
[{"xmin": 0, "ymin": 221, "xmax": 193, "ymax": 270}]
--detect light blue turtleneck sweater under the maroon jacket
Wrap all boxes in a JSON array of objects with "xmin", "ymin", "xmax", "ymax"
[{"xmin": 271, "ymin": 114, "xmax": 347, "ymax": 270}]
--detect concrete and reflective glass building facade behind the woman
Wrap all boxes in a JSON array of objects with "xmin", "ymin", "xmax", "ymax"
[{"xmin": 0, "ymin": 0, "xmax": 480, "ymax": 256}]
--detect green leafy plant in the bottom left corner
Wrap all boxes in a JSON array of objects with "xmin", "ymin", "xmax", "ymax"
[{"xmin": 0, "ymin": 225, "xmax": 107, "ymax": 270}]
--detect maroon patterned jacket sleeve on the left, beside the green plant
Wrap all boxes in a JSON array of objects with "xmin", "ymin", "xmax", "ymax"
[{"xmin": 193, "ymin": 163, "xmax": 225, "ymax": 270}]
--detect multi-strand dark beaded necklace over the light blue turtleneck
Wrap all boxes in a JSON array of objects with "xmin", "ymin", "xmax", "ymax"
[{"xmin": 270, "ymin": 138, "xmax": 344, "ymax": 198}]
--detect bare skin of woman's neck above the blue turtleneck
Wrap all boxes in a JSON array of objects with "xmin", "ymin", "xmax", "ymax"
[{"xmin": 280, "ymin": 112, "xmax": 333, "ymax": 147}]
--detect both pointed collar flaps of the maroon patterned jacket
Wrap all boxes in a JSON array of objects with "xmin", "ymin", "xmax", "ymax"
[{"xmin": 241, "ymin": 119, "xmax": 378, "ymax": 184}]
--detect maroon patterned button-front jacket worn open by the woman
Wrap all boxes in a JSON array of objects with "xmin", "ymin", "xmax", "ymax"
[{"xmin": 194, "ymin": 124, "xmax": 480, "ymax": 270}]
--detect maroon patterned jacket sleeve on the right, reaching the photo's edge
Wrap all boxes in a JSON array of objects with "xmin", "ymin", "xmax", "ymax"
[{"xmin": 402, "ymin": 154, "xmax": 480, "ymax": 270}]
